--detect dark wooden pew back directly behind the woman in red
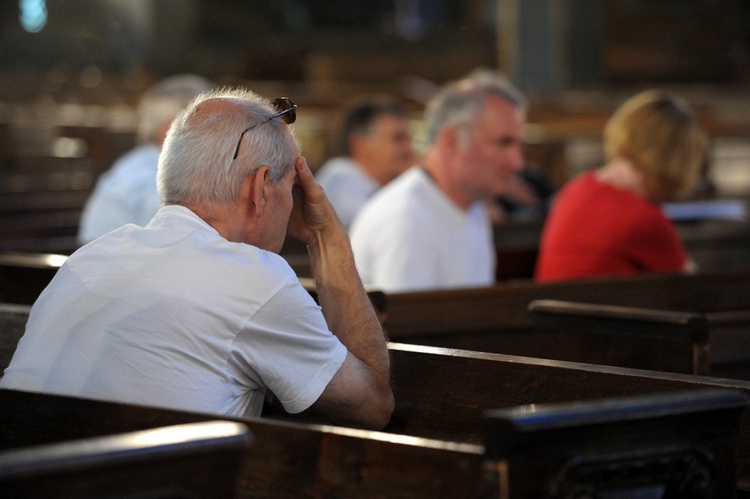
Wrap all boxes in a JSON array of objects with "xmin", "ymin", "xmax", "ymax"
[{"xmin": 384, "ymin": 269, "xmax": 750, "ymax": 341}]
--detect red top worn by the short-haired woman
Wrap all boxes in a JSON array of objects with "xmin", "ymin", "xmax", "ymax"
[{"xmin": 536, "ymin": 172, "xmax": 687, "ymax": 281}]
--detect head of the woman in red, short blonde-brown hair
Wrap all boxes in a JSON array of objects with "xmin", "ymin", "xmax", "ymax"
[{"xmin": 604, "ymin": 90, "xmax": 707, "ymax": 202}]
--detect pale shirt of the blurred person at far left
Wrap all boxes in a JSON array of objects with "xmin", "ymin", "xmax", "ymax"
[{"xmin": 78, "ymin": 144, "xmax": 161, "ymax": 243}]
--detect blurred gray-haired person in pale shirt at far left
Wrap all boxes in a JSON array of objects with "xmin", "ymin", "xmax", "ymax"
[{"xmin": 78, "ymin": 74, "xmax": 212, "ymax": 244}]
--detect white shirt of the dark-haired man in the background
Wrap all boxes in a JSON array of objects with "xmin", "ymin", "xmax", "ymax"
[{"xmin": 315, "ymin": 157, "xmax": 380, "ymax": 227}]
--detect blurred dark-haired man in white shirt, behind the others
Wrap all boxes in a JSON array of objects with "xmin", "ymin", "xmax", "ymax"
[{"xmin": 315, "ymin": 97, "xmax": 415, "ymax": 227}]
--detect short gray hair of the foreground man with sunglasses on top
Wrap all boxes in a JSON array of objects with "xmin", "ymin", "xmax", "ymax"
[{"xmin": 157, "ymin": 88, "xmax": 297, "ymax": 208}]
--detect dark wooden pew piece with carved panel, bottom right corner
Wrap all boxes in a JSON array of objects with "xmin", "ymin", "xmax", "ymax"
[{"xmin": 485, "ymin": 392, "xmax": 748, "ymax": 497}]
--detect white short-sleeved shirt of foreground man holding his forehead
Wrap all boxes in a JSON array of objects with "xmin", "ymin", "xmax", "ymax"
[{"xmin": 0, "ymin": 206, "xmax": 347, "ymax": 417}]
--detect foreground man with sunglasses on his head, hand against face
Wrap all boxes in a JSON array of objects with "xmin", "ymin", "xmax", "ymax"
[{"xmin": 0, "ymin": 89, "xmax": 393, "ymax": 428}]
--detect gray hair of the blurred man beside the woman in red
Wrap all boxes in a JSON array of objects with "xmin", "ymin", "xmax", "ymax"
[{"xmin": 426, "ymin": 69, "xmax": 526, "ymax": 146}]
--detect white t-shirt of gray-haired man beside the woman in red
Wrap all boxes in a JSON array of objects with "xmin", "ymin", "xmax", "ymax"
[{"xmin": 350, "ymin": 167, "xmax": 495, "ymax": 292}]
